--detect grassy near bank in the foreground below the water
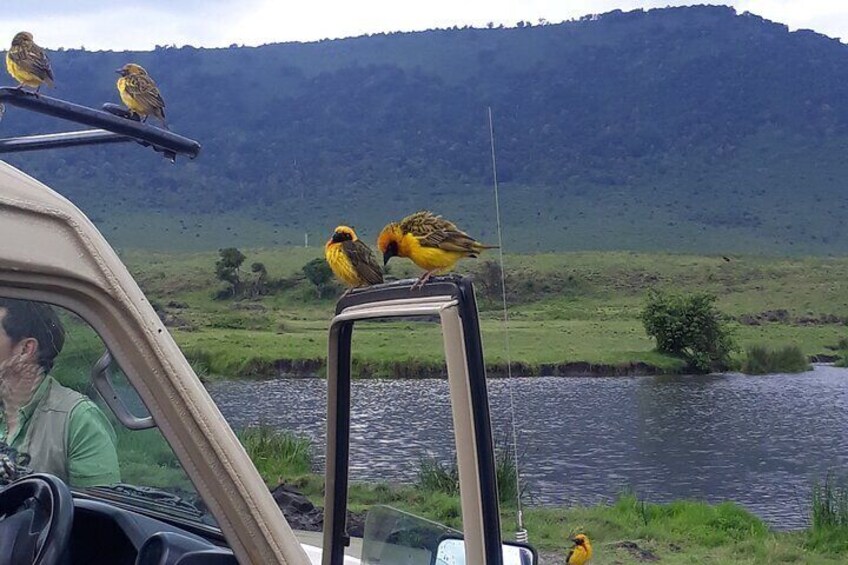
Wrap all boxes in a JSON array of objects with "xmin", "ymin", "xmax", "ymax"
[{"xmin": 272, "ymin": 468, "xmax": 848, "ymax": 565}]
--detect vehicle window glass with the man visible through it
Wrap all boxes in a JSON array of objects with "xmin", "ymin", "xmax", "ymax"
[{"xmin": 0, "ymin": 298, "xmax": 214, "ymax": 525}]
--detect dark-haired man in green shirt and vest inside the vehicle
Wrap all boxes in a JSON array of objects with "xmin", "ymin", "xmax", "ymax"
[{"xmin": 0, "ymin": 298, "xmax": 120, "ymax": 487}]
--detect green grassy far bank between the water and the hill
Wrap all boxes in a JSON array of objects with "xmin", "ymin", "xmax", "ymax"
[{"xmin": 123, "ymin": 248, "xmax": 848, "ymax": 380}]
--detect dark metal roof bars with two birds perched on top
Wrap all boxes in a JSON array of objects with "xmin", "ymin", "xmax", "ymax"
[{"xmin": 0, "ymin": 86, "xmax": 200, "ymax": 162}]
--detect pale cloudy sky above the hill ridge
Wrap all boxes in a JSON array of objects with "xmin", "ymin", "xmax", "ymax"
[{"xmin": 0, "ymin": 0, "xmax": 848, "ymax": 50}]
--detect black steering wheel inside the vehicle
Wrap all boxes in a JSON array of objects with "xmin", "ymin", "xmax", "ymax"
[{"xmin": 0, "ymin": 473, "xmax": 74, "ymax": 565}]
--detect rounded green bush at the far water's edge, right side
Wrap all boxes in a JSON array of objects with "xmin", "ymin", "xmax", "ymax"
[{"xmin": 642, "ymin": 291, "xmax": 736, "ymax": 373}]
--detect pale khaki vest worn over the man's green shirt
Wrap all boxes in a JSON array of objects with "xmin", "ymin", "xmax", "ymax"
[{"xmin": 18, "ymin": 379, "xmax": 85, "ymax": 482}]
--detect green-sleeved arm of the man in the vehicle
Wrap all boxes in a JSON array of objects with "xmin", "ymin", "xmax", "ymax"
[{"xmin": 68, "ymin": 400, "xmax": 121, "ymax": 487}]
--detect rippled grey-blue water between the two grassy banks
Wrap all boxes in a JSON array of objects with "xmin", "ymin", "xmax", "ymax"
[{"xmin": 210, "ymin": 366, "xmax": 848, "ymax": 528}]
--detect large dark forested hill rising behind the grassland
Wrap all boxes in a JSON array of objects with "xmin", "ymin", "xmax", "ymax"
[{"xmin": 0, "ymin": 7, "xmax": 848, "ymax": 254}]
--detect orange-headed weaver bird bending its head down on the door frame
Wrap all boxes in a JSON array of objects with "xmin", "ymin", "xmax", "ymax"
[{"xmin": 377, "ymin": 210, "xmax": 497, "ymax": 286}]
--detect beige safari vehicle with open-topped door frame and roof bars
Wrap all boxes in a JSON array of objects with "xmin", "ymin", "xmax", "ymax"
[{"xmin": 0, "ymin": 88, "xmax": 537, "ymax": 565}]
